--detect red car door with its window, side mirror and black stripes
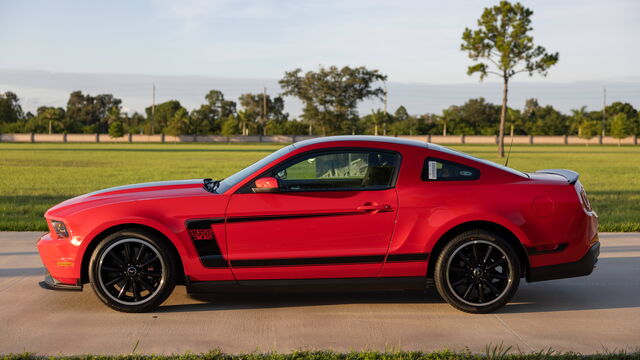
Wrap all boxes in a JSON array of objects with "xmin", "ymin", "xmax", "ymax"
[{"xmin": 226, "ymin": 148, "xmax": 401, "ymax": 280}]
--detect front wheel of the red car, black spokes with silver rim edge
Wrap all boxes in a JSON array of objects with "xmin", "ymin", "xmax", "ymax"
[{"xmin": 89, "ymin": 229, "xmax": 177, "ymax": 312}]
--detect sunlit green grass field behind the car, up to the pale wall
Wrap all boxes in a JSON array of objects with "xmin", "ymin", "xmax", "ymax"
[{"xmin": 0, "ymin": 143, "xmax": 640, "ymax": 231}]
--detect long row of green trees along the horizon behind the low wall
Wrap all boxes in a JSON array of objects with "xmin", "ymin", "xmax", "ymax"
[{"xmin": 0, "ymin": 83, "xmax": 640, "ymax": 139}]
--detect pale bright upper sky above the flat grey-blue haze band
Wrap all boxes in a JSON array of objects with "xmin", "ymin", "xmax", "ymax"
[{"xmin": 0, "ymin": 0, "xmax": 640, "ymax": 84}]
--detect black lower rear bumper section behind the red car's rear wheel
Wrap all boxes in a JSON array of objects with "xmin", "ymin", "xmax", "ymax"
[{"xmin": 527, "ymin": 242, "xmax": 600, "ymax": 282}]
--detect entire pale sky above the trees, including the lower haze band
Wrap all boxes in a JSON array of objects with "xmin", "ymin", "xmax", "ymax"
[{"xmin": 0, "ymin": 0, "xmax": 640, "ymax": 113}]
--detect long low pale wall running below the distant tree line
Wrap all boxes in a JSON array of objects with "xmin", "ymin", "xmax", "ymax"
[{"xmin": 0, "ymin": 134, "xmax": 638, "ymax": 145}]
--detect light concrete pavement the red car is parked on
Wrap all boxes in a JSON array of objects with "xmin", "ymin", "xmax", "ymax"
[{"xmin": 0, "ymin": 232, "xmax": 640, "ymax": 355}]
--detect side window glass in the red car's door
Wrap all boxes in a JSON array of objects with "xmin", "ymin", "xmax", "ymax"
[{"xmin": 272, "ymin": 150, "xmax": 400, "ymax": 191}]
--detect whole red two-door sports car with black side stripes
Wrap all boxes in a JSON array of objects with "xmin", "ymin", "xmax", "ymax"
[{"xmin": 38, "ymin": 136, "xmax": 600, "ymax": 313}]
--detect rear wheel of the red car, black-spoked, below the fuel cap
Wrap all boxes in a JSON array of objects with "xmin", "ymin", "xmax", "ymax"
[{"xmin": 434, "ymin": 230, "xmax": 521, "ymax": 314}]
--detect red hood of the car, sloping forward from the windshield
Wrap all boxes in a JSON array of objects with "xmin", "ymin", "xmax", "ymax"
[{"xmin": 45, "ymin": 179, "xmax": 215, "ymax": 216}]
